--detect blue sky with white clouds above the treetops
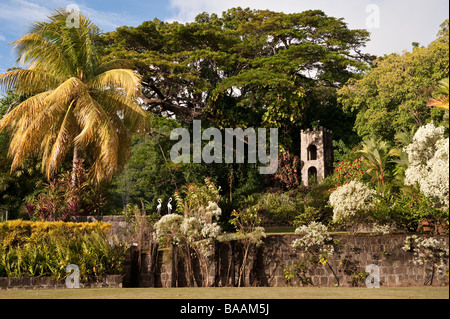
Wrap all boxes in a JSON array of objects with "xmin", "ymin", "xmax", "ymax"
[{"xmin": 0, "ymin": 0, "xmax": 449, "ymax": 94}]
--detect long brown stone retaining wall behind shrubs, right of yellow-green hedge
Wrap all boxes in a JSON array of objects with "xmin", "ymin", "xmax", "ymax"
[{"xmin": 139, "ymin": 235, "xmax": 449, "ymax": 287}]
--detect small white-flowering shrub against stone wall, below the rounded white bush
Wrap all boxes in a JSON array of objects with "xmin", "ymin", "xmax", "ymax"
[{"xmin": 292, "ymin": 222, "xmax": 334, "ymax": 265}]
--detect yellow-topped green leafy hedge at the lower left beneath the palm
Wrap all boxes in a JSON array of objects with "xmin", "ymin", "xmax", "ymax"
[{"xmin": 0, "ymin": 220, "xmax": 126, "ymax": 282}]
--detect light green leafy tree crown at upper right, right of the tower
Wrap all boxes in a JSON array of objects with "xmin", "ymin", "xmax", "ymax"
[{"xmin": 338, "ymin": 20, "xmax": 449, "ymax": 141}]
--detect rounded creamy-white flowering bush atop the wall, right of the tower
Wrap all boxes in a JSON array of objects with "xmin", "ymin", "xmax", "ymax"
[{"xmin": 328, "ymin": 181, "xmax": 376, "ymax": 222}]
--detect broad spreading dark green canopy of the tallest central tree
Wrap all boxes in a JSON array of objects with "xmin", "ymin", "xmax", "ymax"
[{"xmin": 102, "ymin": 8, "xmax": 373, "ymax": 136}]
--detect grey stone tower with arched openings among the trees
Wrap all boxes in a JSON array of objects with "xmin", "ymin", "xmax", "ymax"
[{"xmin": 300, "ymin": 126, "xmax": 333, "ymax": 186}]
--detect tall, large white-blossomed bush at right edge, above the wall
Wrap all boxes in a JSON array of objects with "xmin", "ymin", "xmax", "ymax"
[{"xmin": 405, "ymin": 123, "xmax": 449, "ymax": 210}]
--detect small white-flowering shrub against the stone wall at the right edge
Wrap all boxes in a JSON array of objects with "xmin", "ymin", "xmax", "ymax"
[{"xmin": 402, "ymin": 235, "xmax": 449, "ymax": 285}]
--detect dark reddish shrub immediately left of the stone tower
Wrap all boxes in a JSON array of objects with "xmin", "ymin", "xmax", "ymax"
[{"xmin": 274, "ymin": 152, "xmax": 300, "ymax": 189}]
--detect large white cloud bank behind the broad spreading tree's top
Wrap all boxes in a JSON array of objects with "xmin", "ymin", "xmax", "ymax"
[{"xmin": 169, "ymin": 0, "xmax": 449, "ymax": 55}]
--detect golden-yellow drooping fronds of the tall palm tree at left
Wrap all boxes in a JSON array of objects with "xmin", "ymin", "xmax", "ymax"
[{"xmin": 0, "ymin": 10, "xmax": 147, "ymax": 182}]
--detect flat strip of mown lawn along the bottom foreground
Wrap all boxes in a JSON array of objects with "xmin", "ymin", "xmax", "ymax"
[{"xmin": 0, "ymin": 287, "xmax": 449, "ymax": 299}]
